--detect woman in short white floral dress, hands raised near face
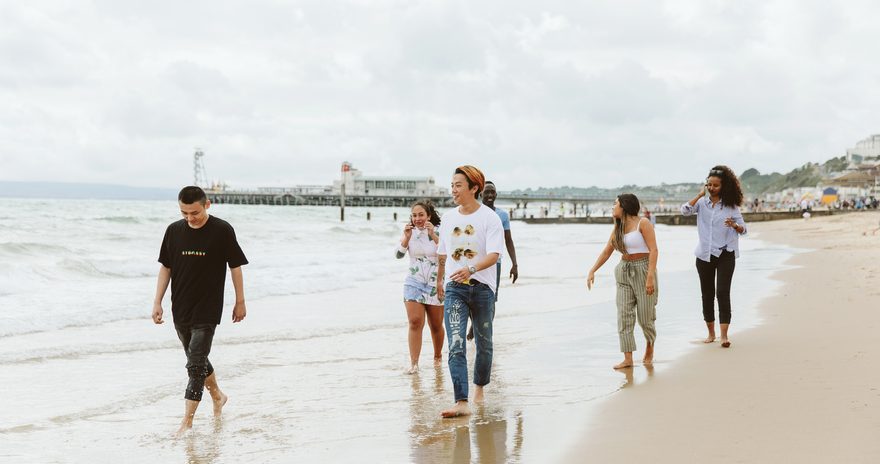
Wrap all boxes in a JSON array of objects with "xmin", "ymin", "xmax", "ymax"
[{"xmin": 397, "ymin": 200, "xmax": 444, "ymax": 374}]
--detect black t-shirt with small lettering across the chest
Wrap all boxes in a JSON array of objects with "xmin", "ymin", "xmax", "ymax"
[{"xmin": 159, "ymin": 216, "xmax": 248, "ymax": 325}]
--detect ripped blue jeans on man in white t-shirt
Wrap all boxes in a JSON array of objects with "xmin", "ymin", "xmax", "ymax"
[{"xmin": 443, "ymin": 280, "xmax": 495, "ymax": 401}]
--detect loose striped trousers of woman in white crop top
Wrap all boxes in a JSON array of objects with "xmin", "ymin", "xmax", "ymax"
[{"xmin": 614, "ymin": 258, "xmax": 658, "ymax": 353}]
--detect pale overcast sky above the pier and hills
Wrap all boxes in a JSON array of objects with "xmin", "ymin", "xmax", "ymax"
[{"xmin": 0, "ymin": 0, "xmax": 880, "ymax": 190}]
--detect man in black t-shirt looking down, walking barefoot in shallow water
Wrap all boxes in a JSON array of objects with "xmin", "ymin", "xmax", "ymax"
[{"xmin": 153, "ymin": 186, "xmax": 248, "ymax": 435}]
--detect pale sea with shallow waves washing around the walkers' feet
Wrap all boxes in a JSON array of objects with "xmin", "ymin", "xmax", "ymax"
[{"xmin": 0, "ymin": 198, "xmax": 800, "ymax": 463}]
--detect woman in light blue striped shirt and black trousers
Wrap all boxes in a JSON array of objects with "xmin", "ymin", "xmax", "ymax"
[{"xmin": 681, "ymin": 166, "xmax": 747, "ymax": 348}]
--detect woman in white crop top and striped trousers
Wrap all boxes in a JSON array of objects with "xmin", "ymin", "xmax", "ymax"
[{"xmin": 587, "ymin": 193, "xmax": 659, "ymax": 369}]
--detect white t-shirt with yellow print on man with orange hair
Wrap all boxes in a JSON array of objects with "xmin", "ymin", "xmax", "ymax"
[{"xmin": 437, "ymin": 204, "xmax": 504, "ymax": 292}]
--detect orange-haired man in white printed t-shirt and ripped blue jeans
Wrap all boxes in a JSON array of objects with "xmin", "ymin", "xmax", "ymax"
[{"xmin": 437, "ymin": 166, "xmax": 504, "ymax": 417}]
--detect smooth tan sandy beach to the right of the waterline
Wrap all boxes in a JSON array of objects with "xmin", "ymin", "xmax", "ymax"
[{"xmin": 563, "ymin": 212, "xmax": 880, "ymax": 463}]
